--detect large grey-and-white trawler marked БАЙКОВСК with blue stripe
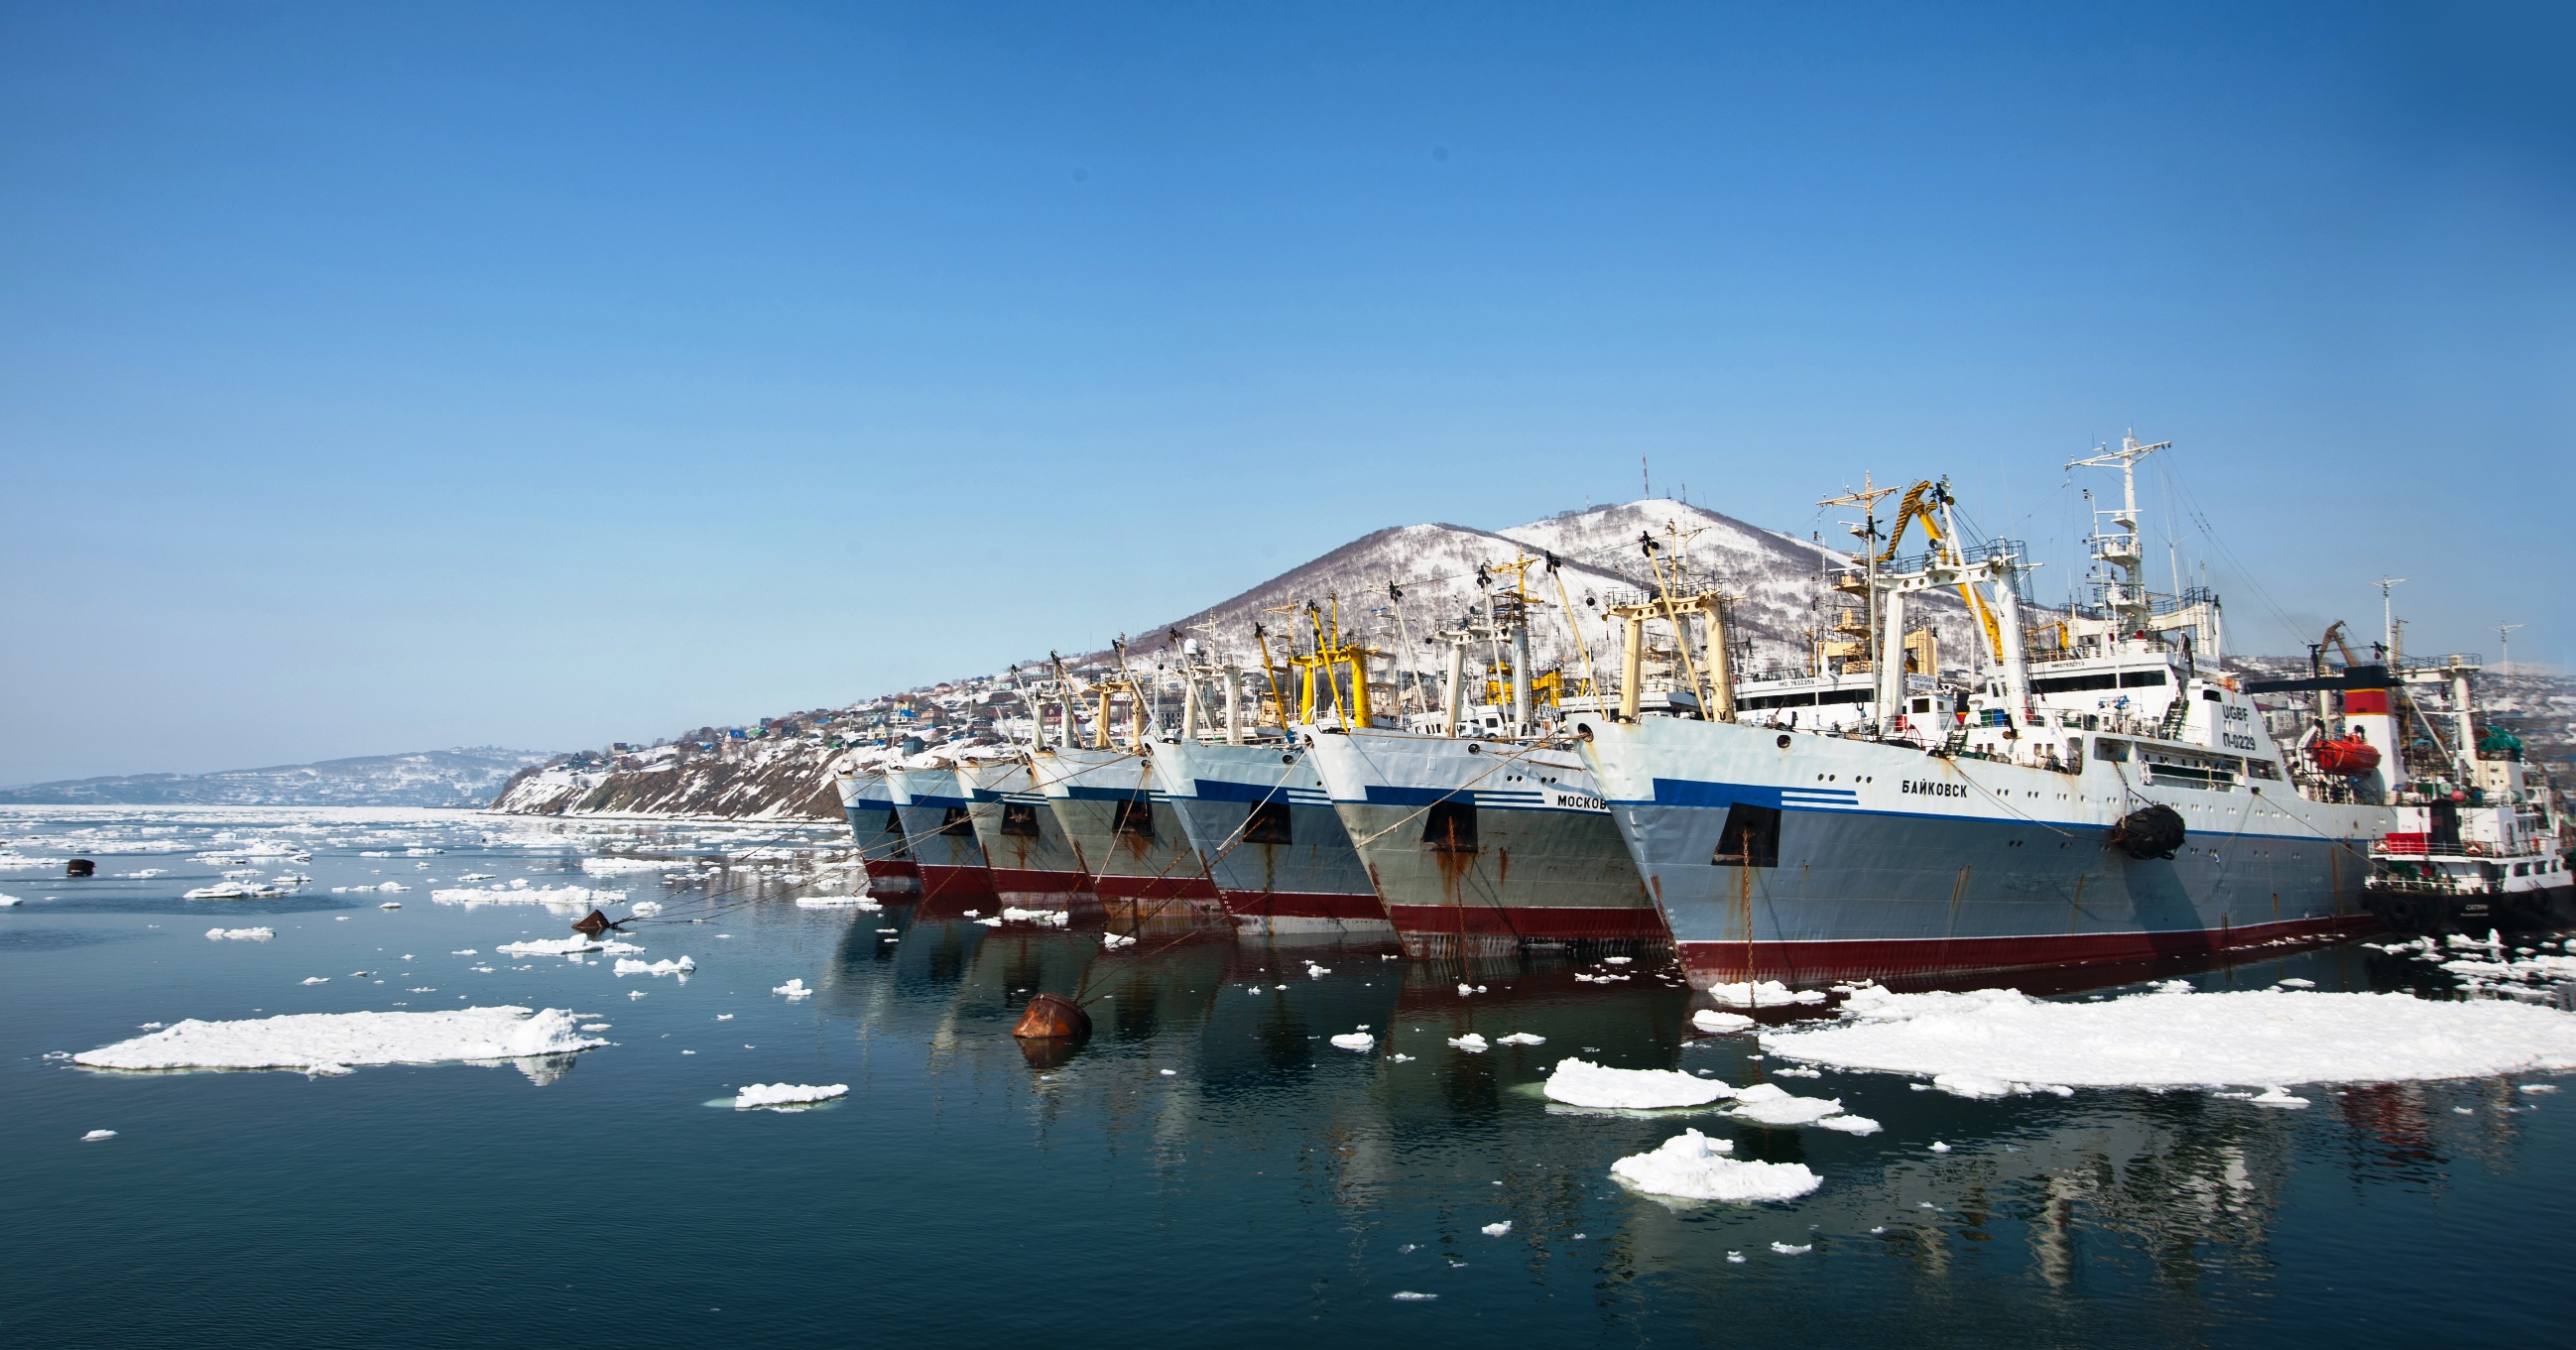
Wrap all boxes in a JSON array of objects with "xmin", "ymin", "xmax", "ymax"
[{"xmin": 1565, "ymin": 438, "xmax": 2391, "ymax": 987}]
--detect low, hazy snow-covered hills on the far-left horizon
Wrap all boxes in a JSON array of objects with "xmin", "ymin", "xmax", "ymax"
[{"xmin": 0, "ymin": 745, "xmax": 552, "ymax": 806}]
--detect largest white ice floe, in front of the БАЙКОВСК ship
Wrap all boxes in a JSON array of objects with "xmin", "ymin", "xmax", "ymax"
[{"xmin": 1762, "ymin": 982, "xmax": 2576, "ymax": 1095}]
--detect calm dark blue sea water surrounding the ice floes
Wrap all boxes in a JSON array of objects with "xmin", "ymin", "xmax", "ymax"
[{"xmin": 0, "ymin": 809, "xmax": 2576, "ymax": 1347}]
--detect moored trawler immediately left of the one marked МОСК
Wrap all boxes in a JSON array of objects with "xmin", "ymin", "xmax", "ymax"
[{"xmin": 1154, "ymin": 639, "xmax": 1391, "ymax": 935}]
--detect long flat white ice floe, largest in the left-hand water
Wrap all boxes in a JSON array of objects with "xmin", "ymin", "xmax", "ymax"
[{"xmin": 72, "ymin": 1008, "xmax": 608, "ymax": 1074}]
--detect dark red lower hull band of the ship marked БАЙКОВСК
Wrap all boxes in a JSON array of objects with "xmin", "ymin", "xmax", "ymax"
[{"xmin": 1682, "ymin": 915, "xmax": 2381, "ymax": 989}]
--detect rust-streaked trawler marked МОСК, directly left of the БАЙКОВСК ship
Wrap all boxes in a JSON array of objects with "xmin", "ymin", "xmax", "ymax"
[{"xmin": 1298, "ymin": 571, "xmax": 1669, "ymax": 958}]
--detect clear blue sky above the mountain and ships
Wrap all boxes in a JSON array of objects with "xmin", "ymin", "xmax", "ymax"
[{"xmin": 0, "ymin": 0, "xmax": 2576, "ymax": 781}]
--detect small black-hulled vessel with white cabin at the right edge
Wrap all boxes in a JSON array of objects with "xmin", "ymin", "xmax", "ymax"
[{"xmin": 2359, "ymin": 655, "xmax": 2576, "ymax": 932}]
